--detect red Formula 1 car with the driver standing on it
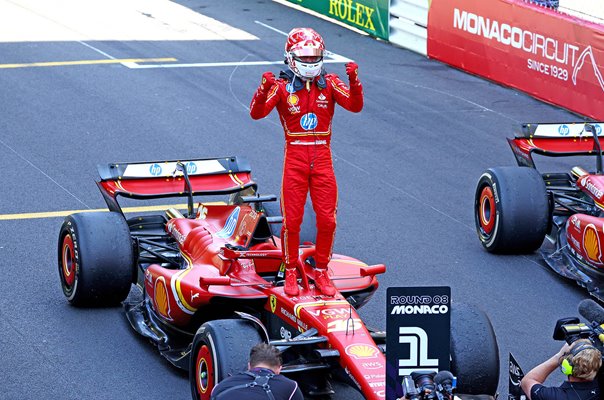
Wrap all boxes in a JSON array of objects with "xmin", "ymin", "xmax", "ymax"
[{"xmin": 58, "ymin": 157, "xmax": 498, "ymax": 400}]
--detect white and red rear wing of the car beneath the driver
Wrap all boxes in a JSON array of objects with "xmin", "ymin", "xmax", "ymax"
[{"xmin": 97, "ymin": 157, "xmax": 256, "ymax": 212}]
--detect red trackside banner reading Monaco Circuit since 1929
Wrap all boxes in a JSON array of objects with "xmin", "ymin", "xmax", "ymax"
[{"xmin": 428, "ymin": 0, "xmax": 604, "ymax": 120}]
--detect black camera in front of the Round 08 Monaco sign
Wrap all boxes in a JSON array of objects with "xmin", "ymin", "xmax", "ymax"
[{"xmin": 402, "ymin": 371, "xmax": 457, "ymax": 400}]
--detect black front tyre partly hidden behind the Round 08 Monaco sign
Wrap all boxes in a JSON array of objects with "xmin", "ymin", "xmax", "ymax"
[{"xmin": 451, "ymin": 304, "xmax": 499, "ymax": 396}]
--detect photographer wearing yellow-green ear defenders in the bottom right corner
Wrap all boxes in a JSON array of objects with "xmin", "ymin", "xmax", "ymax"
[{"xmin": 520, "ymin": 339, "xmax": 602, "ymax": 400}]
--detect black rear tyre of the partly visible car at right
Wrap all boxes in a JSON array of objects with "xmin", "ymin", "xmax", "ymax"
[{"xmin": 474, "ymin": 167, "xmax": 550, "ymax": 253}]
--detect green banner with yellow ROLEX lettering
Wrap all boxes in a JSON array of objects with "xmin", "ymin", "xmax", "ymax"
[{"xmin": 288, "ymin": 0, "xmax": 390, "ymax": 40}]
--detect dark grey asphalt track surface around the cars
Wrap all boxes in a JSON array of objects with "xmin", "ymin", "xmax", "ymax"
[{"xmin": 0, "ymin": 0, "xmax": 591, "ymax": 400}]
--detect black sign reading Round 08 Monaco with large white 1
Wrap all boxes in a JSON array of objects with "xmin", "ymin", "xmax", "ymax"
[{"xmin": 386, "ymin": 286, "xmax": 451, "ymax": 399}]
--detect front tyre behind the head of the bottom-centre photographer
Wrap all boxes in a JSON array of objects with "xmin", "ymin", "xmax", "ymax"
[{"xmin": 189, "ymin": 319, "xmax": 263, "ymax": 400}]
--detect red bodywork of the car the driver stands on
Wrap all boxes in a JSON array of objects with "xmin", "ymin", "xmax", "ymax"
[{"xmin": 145, "ymin": 205, "xmax": 385, "ymax": 399}]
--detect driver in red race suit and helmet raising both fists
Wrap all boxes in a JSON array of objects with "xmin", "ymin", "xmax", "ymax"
[{"xmin": 250, "ymin": 28, "xmax": 363, "ymax": 296}]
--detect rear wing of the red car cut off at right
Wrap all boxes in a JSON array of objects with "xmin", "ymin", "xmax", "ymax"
[{"xmin": 508, "ymin": 122, "xmax": 604, "ymax": 168}]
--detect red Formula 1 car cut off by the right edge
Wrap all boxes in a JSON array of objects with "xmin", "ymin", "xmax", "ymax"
[{"xmin": 474, "ymin": 123, "xmax": 604, "ymax": 301}]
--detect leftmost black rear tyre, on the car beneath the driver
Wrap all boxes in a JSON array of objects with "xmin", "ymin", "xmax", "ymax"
[{"xmin": 58, "ymin": 212, "xmax": 135, "ymax": 306}]
